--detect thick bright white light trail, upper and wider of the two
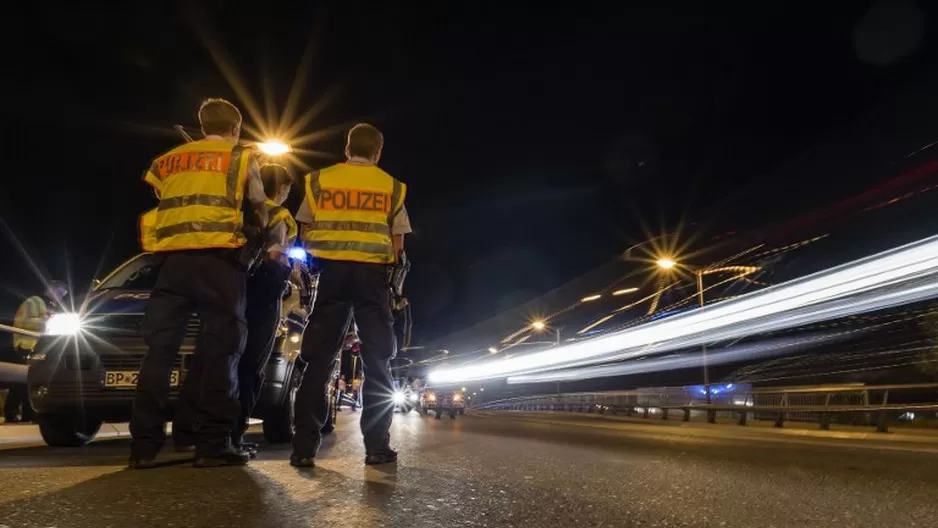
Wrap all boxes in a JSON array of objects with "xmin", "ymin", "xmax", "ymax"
[{"xmin": 430, "ymin": 237, "xmax": 938, "ymax": 384}]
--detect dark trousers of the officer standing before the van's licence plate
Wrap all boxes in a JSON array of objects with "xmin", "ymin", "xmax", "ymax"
[{"xmin": 130, "ymin": 249, "xmax": 247, "ymax": 457}]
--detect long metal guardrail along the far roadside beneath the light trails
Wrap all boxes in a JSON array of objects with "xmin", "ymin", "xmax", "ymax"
[{"xmin": 473, "ymin": 383, "xmax": 938, "ymax": 433}]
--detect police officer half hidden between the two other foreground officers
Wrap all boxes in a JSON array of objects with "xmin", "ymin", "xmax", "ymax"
[{"xmin": 173, "ymin": 164, "xmax": 297, "ymax": 458}]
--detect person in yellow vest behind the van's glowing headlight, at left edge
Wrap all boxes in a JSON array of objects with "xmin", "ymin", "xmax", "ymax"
[{"xmin": 3, "ymin": 281, "xmax": 68, "ymax": 423}]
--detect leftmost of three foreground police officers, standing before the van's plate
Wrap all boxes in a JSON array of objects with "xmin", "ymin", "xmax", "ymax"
[{"xmin": 129, "ymin": 99, "xmax": 267, "ymax": 469}]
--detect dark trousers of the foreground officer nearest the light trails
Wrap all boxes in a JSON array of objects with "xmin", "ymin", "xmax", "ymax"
[{"xmin": 293, "ymin": 260, "xmax": 395, "ymax": 456}]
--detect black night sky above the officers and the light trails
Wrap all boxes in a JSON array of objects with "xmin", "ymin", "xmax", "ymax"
[{"xmin": 0, "ymin": 0, "xmax": 938, "ymax": 337}]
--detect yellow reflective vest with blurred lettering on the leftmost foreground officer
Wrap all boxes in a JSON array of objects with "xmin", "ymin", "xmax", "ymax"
[{"xmin": 140, "ymin": 139, "xmax": 251, "ymax": 252}]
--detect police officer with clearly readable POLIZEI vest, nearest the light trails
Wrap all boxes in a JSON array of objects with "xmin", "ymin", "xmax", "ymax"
[{"xmin": 290, "ymin": 124, "xmax": 410, "ymax": 467}]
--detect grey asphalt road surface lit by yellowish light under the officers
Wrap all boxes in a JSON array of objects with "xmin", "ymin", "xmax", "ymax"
[{"xmin": 0, "ymin": 413, "xmax": 938, "ymax": 528}]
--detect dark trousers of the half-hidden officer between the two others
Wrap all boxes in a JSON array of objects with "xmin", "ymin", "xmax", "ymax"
[{"xmin": 173, "ymin": 260, "xmax": 290, "ymax": 446}]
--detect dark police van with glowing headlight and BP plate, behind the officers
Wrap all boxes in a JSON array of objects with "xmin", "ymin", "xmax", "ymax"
[{"xmin": 27, "ymin": 253, "xmax": 338, "ymax": 447}]
